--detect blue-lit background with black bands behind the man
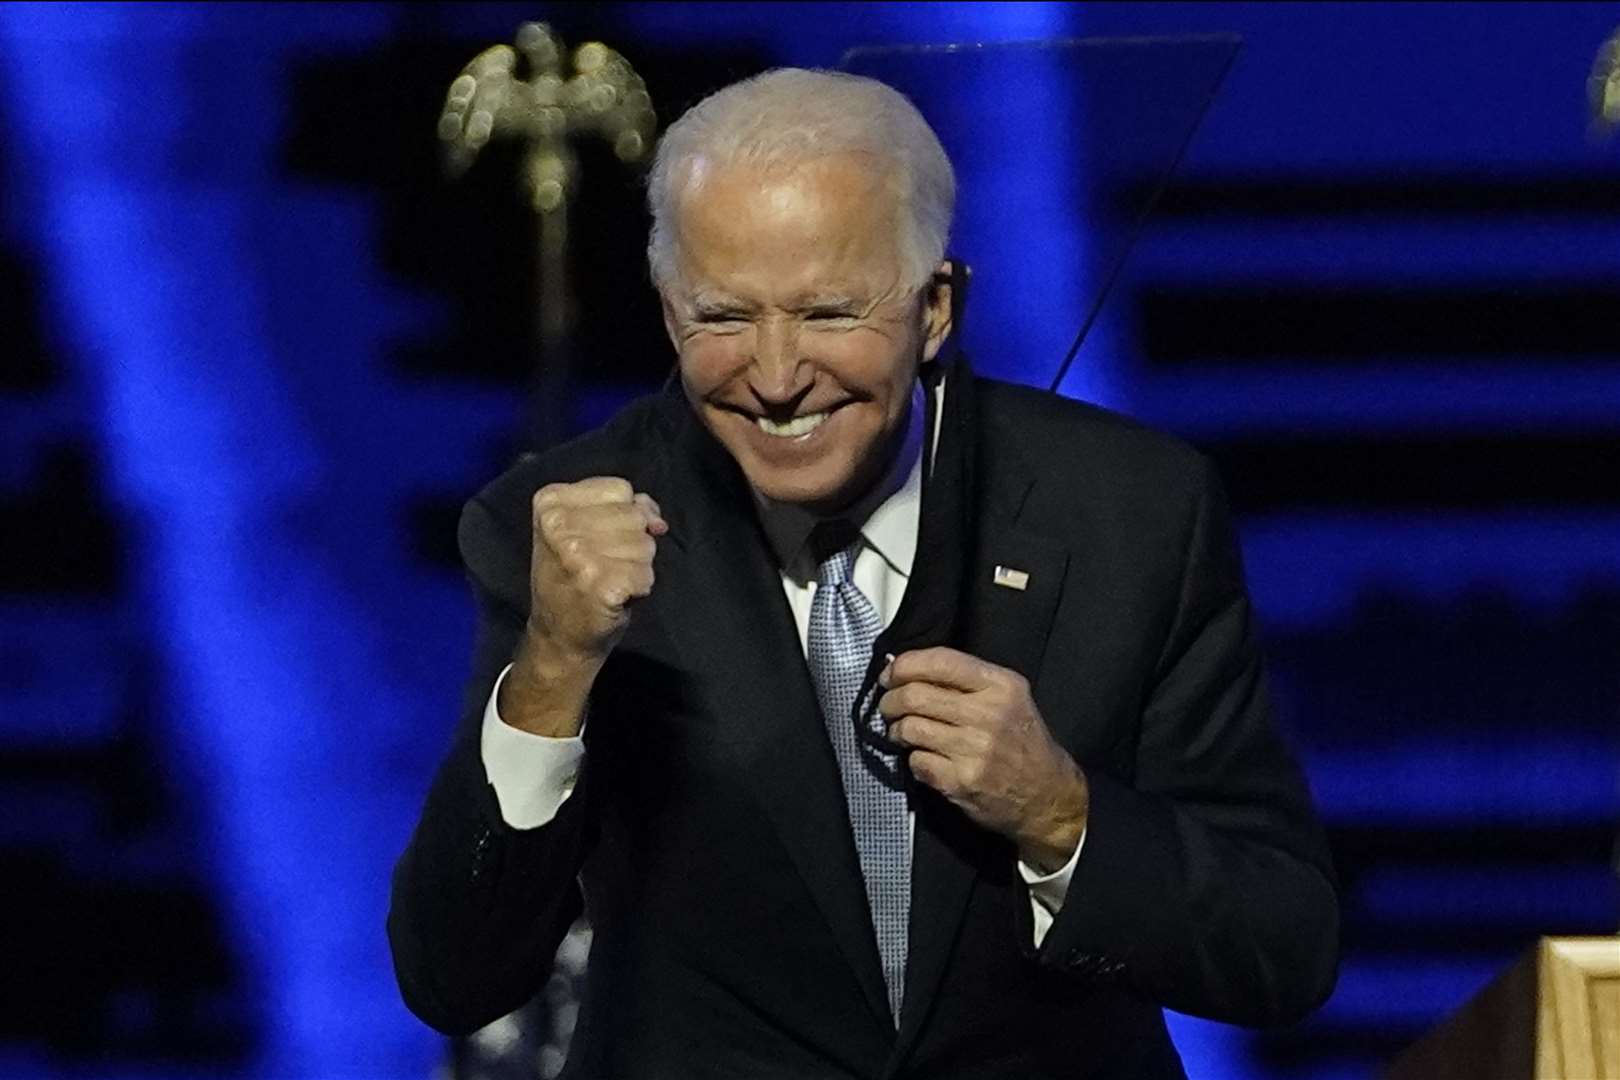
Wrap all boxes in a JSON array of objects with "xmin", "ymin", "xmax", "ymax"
[{"xmin": 0, "ymin": 3, "xmax": 1620, "ymax": 1080}]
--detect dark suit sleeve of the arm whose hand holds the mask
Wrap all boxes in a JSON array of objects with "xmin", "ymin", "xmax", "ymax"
[{"xmin": 1038, "ymin": 463, "xmax": 1338, "ymax": 1025}]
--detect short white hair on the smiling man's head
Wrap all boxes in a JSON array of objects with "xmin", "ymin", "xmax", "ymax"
[{"xmin": 646, "ymin": 68, "xmax": 956, "ymax": 288}]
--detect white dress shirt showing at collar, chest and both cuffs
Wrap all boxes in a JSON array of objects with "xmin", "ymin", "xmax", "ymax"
[{"xmin": 480, "ymin": 384, "xmax": 1085, "ymax": 947}]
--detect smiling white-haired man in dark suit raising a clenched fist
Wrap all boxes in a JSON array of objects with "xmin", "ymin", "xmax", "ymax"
[{"xmin": 389, "ymin": 70, "xmax": 1337, "ymax": 1077}]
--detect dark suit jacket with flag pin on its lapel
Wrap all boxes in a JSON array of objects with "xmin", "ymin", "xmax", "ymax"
[{"xmin": 389, "ymin": 359, "xmax": 1338, "ymax": 1078}]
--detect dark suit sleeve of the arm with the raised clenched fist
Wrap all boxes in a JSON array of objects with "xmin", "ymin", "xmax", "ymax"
[{"xmin": 387, "ymin": 500, "xmax": 591, "ymax": 1035}]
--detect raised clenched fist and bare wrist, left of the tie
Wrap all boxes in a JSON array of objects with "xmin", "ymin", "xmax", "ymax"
[{"xmin": 497, "ymin": 476, "xmax": 669, "ymax": 737}]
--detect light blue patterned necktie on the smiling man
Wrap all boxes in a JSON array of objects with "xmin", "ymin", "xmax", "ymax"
[{"xmin": 810, "ymin": 526, "xmax": 910, "ymax": 1027}]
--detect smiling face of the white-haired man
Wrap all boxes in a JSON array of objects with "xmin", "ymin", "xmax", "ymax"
[{"xmin": 663, "ymin": 155, "xmax": 951, "ymax": 513}]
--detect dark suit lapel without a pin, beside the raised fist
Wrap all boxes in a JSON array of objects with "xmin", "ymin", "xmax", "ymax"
[{"xmin": 654, "ymin": 395, "xmax": 893, "ymax": 1030}]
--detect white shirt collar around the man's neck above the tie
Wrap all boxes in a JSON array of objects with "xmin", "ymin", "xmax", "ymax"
[{"xmin": 753, "ymin": 382, "xmax": 927, "ymax": 581}]
